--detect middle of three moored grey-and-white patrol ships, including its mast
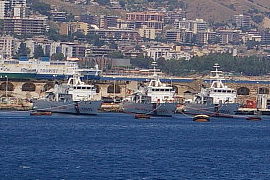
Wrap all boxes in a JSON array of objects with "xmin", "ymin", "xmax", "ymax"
[{"xmin": 122, "ymin": 62, "xmax": 177, "ymax": 116}]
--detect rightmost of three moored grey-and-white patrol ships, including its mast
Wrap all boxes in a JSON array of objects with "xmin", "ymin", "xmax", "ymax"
[{"xmin": 184, "ymin": 64, "xmax": 239, "ymax": 117}]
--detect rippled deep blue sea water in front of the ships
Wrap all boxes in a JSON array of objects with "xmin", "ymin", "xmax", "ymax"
[{"xmin": 0, "ymin": 112, "xmax": 270, "ymax": 180}]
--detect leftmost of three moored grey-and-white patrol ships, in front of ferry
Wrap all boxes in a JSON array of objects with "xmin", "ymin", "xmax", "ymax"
[{"xmin": 33, "ymin": 74, "xmax": 101, "ymax": 115}]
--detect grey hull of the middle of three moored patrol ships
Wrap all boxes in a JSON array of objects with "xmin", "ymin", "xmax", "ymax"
[{"xmin": 122, "ymin": 102, "xmax": 176, "ymax": 117}]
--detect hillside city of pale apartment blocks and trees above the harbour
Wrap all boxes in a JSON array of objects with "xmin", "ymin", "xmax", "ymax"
[{"xmin": 0, "ymin": 0, "xmax": 270, "ymax": 75}]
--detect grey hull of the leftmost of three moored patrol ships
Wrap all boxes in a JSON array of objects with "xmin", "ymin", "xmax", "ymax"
[{"xmin": 33, "ymin": 100, "xmax": 101, "ymax": 115}]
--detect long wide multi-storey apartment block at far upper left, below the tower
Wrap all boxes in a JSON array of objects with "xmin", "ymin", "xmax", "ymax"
[{"xmin": 4, "ymin": 16, "xmax": 47, "ymax": 35}]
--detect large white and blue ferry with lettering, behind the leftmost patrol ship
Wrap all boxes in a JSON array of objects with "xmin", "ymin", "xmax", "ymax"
[{"xmin": 0, "ymin": 59, "xmax": 101, "ymax": 80}]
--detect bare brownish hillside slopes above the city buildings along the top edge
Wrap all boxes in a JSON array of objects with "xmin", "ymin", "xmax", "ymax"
[{"xmin": 39, "ymin": 0, "xmax": 270, "ymax": 22}]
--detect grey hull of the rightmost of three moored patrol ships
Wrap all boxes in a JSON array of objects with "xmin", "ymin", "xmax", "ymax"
[{"xmin": 184, "ymin": 103, "xmax": 239, "ymax": 117}]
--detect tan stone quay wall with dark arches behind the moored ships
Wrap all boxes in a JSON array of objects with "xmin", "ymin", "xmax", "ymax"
[{"xmin": 0, "ymin": 79, "xmax": 270, "ymax": 104}]
